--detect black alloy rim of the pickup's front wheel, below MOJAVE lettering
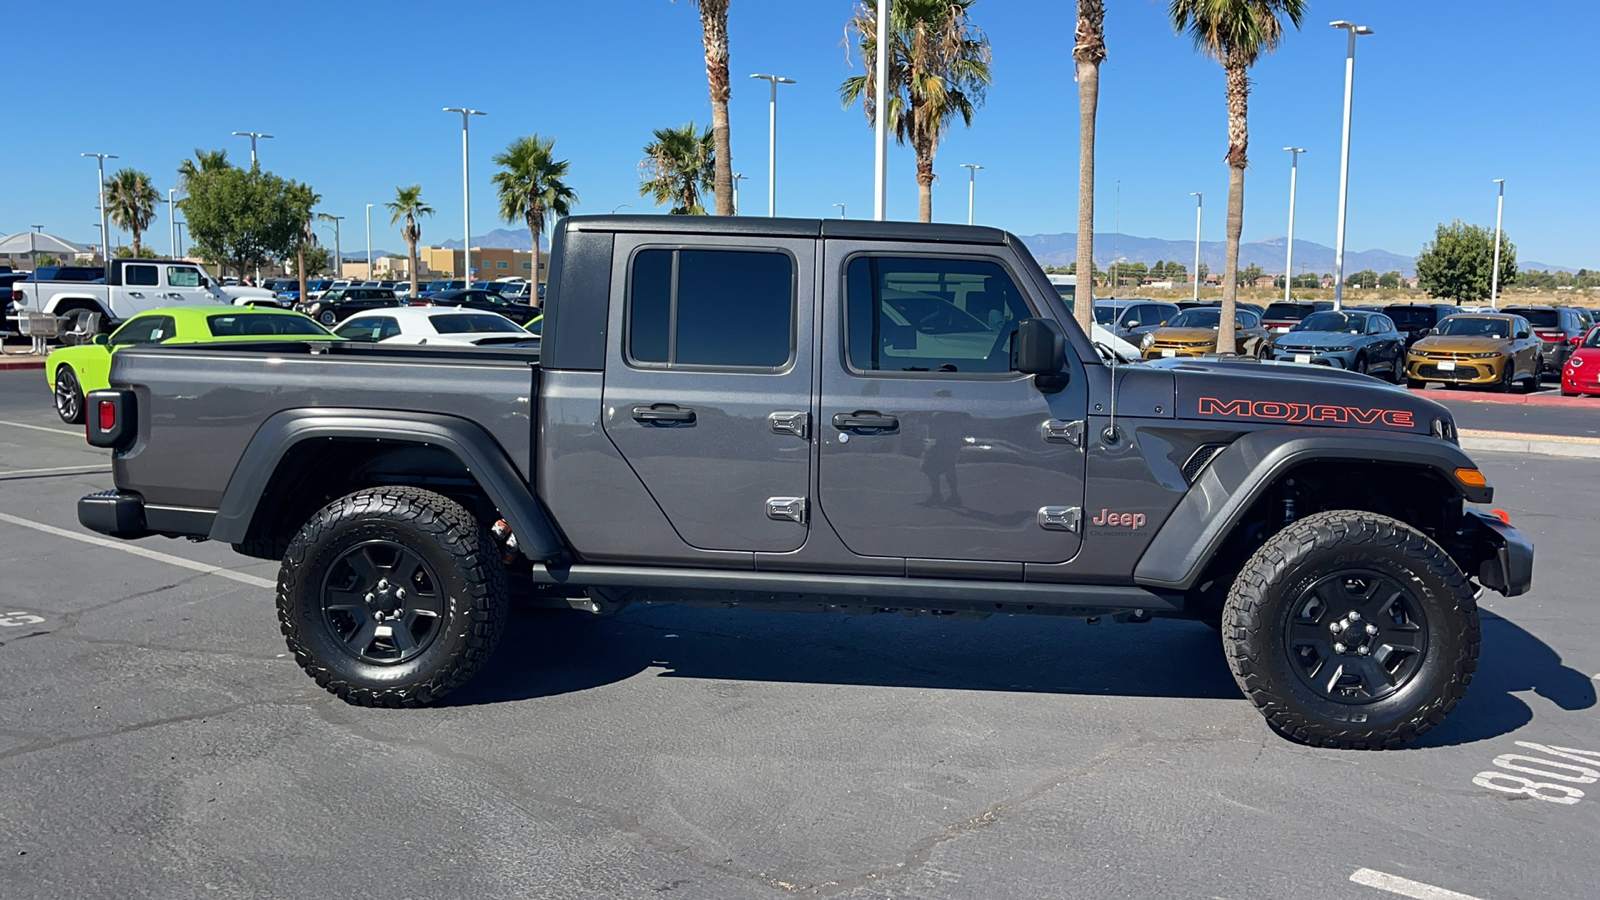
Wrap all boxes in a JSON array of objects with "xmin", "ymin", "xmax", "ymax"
[{"xmin": 1283, "ymin": 570, "xmax": 1427, "ymax": 705}]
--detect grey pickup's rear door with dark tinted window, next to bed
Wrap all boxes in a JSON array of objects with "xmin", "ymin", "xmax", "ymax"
[{"xmin": 603, "ymin": 234, "xmax": 816, "ymax": 551}]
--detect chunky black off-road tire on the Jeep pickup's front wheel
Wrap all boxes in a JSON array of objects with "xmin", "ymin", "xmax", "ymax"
[{"xmin": 1222, "ymin": 509, "xmax": 1480, "ymax": 749}]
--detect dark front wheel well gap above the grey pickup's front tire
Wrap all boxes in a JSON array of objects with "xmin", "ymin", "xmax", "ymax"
[{"xmin": 1194, "ymin": 460, "xmax": 1474, "ymax": 610}]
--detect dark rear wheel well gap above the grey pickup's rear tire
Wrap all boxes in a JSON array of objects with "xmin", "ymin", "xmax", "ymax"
[{"xmin": 234, "ymin": 437, "xmax": 499, "ymax": 559}]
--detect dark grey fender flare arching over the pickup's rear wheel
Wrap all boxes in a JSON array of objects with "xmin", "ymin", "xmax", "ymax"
[{"xmin": 210, "ymin": 408, "xmax": 563, "ymax": 560}]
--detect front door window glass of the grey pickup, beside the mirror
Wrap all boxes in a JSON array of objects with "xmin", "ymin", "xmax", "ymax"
[{"xmin": 845, "ymin": 256, "xmax": 1032, "ymax": 373}]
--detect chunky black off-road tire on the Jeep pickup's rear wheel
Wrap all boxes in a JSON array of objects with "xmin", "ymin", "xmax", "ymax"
[{"xmin": 278, "ymin": 487, "xmax": 507, "ymax": 706}]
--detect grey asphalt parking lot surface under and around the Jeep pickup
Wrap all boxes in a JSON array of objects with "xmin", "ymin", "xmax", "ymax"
[{"xmin": 0, "ymin": 372, "xmax": 1600, "ymax": 900}]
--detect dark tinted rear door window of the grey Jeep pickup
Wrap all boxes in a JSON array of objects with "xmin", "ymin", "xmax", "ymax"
[{"xmin": 627, "ymin": 250, "xmax": 795, "ymax": 368}]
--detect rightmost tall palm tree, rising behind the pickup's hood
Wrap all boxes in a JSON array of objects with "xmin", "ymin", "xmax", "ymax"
[{"xmin": 1166, "ymin": 0, "xmax": 1306, "ymax": 352}]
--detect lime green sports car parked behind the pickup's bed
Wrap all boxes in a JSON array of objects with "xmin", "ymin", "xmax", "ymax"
[{"xmin": 45, "ymin": 306, "xmax": 342, "ymax": 424}]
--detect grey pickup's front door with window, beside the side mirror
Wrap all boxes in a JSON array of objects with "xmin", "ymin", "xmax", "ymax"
[{"xmin": 818, "ymin": 240, "xmax": 1088, "ymax": 560}]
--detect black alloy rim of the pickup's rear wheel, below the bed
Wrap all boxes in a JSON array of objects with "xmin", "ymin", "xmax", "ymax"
[{"xmin": 322, "ymin": 540, "xmax": 445, "ymax": 665}]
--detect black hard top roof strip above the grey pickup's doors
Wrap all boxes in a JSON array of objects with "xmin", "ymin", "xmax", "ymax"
[{"xmin": 562, "ymin": 216, "xmax": 1016, "ymax": 243}]
